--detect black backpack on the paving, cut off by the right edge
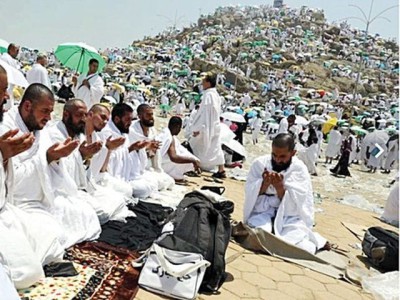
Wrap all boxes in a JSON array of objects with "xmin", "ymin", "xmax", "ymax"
[{"xmin": 362, "ymin": 227, "xmax": 399, "ymax": 271}]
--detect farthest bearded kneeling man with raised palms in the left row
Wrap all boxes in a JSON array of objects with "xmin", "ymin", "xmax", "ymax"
[{"xmin": 129, "ymin": 104, "xmax": 175, "ymax": 191}]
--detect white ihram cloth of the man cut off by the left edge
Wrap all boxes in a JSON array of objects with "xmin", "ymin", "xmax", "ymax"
[{"xmin": 0, "ymin": 152, "xmax": 64, "ymax": 288}]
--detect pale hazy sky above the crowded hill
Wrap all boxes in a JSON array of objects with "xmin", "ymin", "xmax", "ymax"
[{"xmin": 0, "ymin": 0, "xmax": 399, "ymax": 50}]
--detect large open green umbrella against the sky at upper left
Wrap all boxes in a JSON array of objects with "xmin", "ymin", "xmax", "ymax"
[{"xmin": 54, "ymin": 43, "xmax": 106, "ymax": 74}]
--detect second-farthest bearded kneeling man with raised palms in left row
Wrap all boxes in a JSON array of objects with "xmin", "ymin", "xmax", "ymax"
[{"xmin": 99, "ymin": 103, "xmax": 158, "ymax": 199}]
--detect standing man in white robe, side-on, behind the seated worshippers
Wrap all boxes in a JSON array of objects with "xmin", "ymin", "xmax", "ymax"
[{"xmin": 189, "ymin": 74, "xmax": 226, "ymax": 178}]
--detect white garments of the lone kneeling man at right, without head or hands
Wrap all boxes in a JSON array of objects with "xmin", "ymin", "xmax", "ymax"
[{"xmin": 243, "ymin": 155, "xmax": 326, "ymax": 254}]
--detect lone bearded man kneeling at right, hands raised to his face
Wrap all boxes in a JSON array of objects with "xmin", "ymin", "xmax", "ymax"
[{"xmin": 243, "ymin": 133, "xmax": 328, "ymax": 254}]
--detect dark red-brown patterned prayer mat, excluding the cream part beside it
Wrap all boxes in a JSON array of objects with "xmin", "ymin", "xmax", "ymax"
[{"xmin": 64, "ymin": 242, "xmax": 139, "ymax": 300}]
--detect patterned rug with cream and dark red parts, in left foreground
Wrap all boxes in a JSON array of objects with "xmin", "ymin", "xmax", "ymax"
[{"xmin": 19, "ymin": 242, "xmax": 139, "ymax": 300}]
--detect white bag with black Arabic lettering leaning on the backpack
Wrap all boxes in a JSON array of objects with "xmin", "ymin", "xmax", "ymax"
[{"xmin": 139, "ymin": 243, "xmax": 210, "ymax": 299}]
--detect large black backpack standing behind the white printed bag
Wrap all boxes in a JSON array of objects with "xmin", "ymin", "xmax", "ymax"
[{"xmin": 158, "ymin": 191, "xmax": 234, "ymax": 292}]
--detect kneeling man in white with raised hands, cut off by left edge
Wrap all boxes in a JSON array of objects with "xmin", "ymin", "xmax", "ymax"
[{"xmin": 0, "ymin": 66, "xmax": 64, "ymax": 288}]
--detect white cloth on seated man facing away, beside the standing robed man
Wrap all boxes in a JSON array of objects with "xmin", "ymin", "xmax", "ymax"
[{"xmin": 159, "ymin": 128, "xmax": 198, "ymax": 180}]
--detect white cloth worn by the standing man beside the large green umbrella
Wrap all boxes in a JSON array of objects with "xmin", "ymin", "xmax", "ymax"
[{"xmin": 72, "ymin": 74, "xmax": 104, "ymax": 109}]
